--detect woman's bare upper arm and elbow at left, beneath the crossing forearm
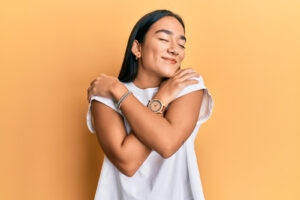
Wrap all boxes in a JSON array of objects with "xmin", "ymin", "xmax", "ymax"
[{"xmin": 92, "ymin": 101, "xmax": 152, "ymax": 176}]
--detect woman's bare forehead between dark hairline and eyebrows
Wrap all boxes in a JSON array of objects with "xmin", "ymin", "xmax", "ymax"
[{"xmin": 149, "ymin": 16, "xmax": 184, "ymax": 35}]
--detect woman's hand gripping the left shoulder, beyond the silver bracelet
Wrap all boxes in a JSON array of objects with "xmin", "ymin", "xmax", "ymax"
[{"xmin": 87, "ymin": 74, "xmax": 119, "ymax": 102}]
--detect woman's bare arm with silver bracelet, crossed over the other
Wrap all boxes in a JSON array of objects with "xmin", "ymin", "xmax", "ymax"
[{"xmin": 112, "ymin": 81, "xmax": 203, "ymax": 158}]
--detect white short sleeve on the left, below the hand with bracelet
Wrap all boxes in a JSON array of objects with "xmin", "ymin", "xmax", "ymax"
[{"xmin": 86, "ymin": 96, "xmax": 120, "ymax": 134}]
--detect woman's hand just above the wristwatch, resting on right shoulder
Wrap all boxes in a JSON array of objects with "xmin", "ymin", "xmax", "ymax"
[{"xmin": 154, "ymin": 68, "xmax": 200, "ymax": 106}]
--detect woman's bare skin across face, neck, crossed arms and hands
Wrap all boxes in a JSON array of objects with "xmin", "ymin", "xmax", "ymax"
[{"xmin": 88, "ymin": 16, "xmax": 203, "ymax": 176}]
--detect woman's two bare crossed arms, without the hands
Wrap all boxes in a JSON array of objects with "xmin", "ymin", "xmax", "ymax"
[{"xmin": 92, "ymin": 82, "xmax": 203, "ymax": 176}]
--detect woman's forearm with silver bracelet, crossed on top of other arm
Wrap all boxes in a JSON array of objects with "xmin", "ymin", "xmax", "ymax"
[{"xmin": 112, "ymin": 84, "xmax": 175, "ymax": 156}]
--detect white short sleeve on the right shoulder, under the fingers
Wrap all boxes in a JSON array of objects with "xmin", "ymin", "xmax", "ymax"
[{"xmin": 176, "ymin": 76, "xmax": 214, "ymax": 124}]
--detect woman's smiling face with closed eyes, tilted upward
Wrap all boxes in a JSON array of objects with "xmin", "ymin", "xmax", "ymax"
[{"xmin": 139, "ymin": 16, "xmax": 186, "ymax": 77}]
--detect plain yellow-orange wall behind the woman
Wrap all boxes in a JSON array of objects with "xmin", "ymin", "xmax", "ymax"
[{"xmin": 0, "ymin": 0, "xmax": 300, "ymax": 200}]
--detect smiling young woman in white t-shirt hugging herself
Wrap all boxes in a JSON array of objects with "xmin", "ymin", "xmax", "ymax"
[{"xmin": 87, "ymin": 10, "xmax": 213, "ymax": 200}]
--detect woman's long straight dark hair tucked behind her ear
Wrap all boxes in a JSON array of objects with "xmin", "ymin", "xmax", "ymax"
[{"xmin": 118, "ymin": 10, "xmax": 185, "ymax": 82}]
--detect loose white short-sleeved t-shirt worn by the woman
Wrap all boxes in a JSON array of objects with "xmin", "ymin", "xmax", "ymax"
[{"xmin": 87, "ymin": 76, "xmax": 213, "ymax": 200}]
